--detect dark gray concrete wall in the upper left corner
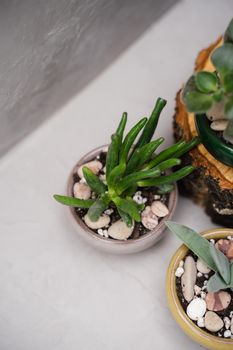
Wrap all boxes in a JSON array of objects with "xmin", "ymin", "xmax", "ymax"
[{"xmin": 0, "ymin": 0, "xmax": 177, "ymax": 155}]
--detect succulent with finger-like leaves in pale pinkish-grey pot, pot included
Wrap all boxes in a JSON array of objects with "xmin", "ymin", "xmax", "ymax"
[{"xmin": 54, "ymin": 98, "xmax": 198, "ymax": 253}]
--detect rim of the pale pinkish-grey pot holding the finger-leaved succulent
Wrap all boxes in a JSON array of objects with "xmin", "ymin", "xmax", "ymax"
[{"xmin": 67, "ymin": 144, "xmax": 178, "ymax": 246}]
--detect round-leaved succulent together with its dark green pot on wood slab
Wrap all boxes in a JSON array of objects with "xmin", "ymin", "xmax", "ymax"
[{"xmin": 182, "ymin": 20, "xmax": 233, "ymax": 166}]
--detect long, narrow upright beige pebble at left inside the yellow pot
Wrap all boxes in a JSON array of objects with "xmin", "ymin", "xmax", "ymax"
[{"xmin": 181, "ymin": 256, "xmax": 197, "ymax": 302}]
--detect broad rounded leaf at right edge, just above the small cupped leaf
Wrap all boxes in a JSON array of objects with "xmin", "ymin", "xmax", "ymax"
[{"xmin": 211, "ymin": 43, "xmax": 233, "ymax": 76}]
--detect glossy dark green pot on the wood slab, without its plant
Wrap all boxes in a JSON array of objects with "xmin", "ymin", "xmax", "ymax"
[{"xmin": 195, "ymin": 114, "xmax": 233, "ymax": 167}]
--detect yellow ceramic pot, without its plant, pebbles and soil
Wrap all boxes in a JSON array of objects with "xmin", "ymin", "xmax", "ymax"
[{"xmin": 166, "ymin": 228, "xmax": 233, "ymax": 350}]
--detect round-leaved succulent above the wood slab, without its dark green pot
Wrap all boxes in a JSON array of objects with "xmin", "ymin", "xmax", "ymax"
[{"xmin": 182, "ymin": 19, "xmax": 233, "ymax": 143}]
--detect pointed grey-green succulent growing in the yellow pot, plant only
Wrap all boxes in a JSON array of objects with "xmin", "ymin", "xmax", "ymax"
[{"xmin": 166, "ymin": 221, "xmax": 233, "ymax": 292}]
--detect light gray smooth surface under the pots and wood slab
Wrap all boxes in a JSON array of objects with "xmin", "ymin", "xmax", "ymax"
[{"xmin": 0, "ymin": 0, "xmax": 233, "ymax": 350}]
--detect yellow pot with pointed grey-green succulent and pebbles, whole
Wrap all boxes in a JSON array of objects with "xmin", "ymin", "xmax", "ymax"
[{"xmin": 166, "ymin": 221, "xmax": 233, "ymax": 350}]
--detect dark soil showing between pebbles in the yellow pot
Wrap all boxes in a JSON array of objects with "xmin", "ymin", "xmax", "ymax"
[{"xmin": 176, "ymin": 247, "xmax": 233, "ymax": 337}]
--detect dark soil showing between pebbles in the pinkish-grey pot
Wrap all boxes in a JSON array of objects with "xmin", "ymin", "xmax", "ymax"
[{"xmin": 73, "ymin": 152, "xmax": 169, "ymax": 240}]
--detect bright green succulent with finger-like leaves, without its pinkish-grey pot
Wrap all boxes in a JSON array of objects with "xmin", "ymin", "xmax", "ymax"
[{"xmin": 54, "ymin": 98, "xmax": 199, "ymax": 226}]
